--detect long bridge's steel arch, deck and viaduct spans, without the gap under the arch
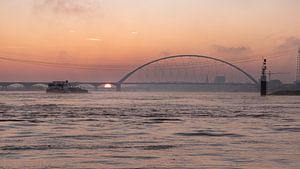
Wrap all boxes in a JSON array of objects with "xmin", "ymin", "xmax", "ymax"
[{"xmin": 0, "ymin": 55, "xmax": 258, "ymax": 91}]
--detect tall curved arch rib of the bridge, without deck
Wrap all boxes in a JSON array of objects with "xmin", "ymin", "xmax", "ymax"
[{"xmin": 117, "ymin": 55, "xmax": 258, "ymax": 86}]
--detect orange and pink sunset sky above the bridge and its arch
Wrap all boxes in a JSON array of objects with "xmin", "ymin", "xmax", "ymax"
[{"xmin": 0, "ymin": 0, "xmax": 300, "ymax": 82}]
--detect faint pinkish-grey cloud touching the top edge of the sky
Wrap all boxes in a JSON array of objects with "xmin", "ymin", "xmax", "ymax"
[{"xmin": 34, "ymin": 0, "xmax": 96, "ymax": 15}]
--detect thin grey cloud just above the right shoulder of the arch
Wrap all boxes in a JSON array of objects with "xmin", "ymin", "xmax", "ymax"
[{"xmin": 213, "ymin": 45, "xmax": 252, "ymax": 56}]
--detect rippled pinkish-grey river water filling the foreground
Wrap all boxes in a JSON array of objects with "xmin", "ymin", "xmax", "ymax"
[{"xmin": 0, "ymin": 92, "xmax": 300, "ymax": 169}]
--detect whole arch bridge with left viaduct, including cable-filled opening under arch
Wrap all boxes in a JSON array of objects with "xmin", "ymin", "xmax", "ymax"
[{"xmin": 0, "ymin": 55, "xmax": 258, "ymax": 91}]
